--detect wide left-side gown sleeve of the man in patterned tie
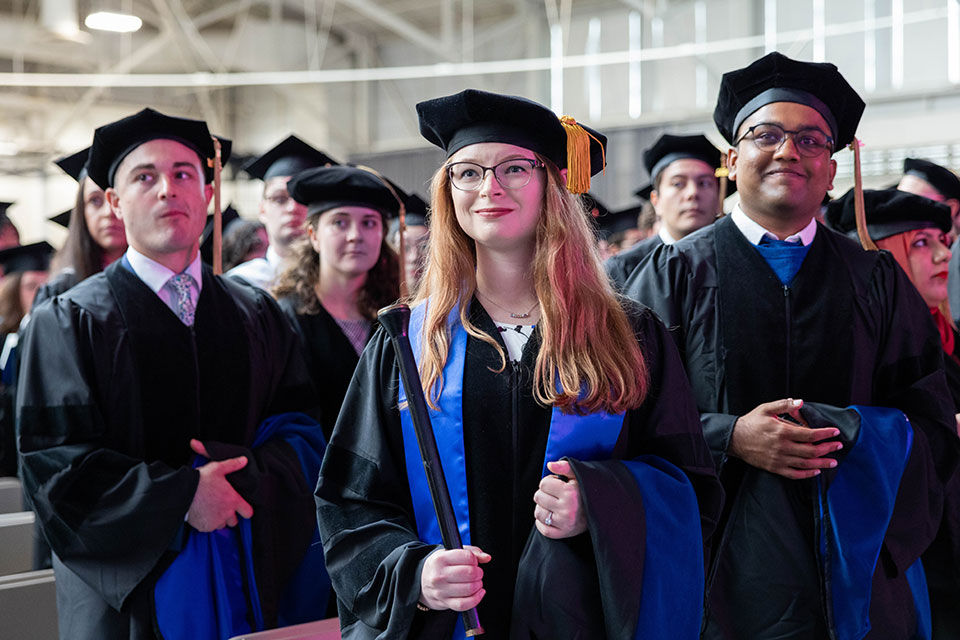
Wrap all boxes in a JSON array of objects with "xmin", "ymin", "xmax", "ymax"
[{"xmin": 17, "ymin": 298, "xmax": 199, "ymax": 610}]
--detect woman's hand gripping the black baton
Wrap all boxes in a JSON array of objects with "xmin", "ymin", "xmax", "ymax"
[{"xmin": 420, "ymin": 545, "xmax": 491, "ymax": 611}]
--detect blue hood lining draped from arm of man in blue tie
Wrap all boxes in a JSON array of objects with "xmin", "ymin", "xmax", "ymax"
[{"xmin": 817, "ymin": 406, "xmax": 931, "ymax": 640}]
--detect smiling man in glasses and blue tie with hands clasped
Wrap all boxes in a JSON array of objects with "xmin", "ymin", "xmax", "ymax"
[{"xmin": 625, "ymin": 53, "xmax": 960, "ymax": 640}]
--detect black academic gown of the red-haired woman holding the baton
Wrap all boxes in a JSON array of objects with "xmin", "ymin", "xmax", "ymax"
[{"xmin": 316, "ymin": 301, "xmax": 722, "ymax": 638}]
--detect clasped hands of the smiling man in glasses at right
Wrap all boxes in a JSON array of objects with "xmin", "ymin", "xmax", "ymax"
[{"xmin": 728, "ymin": 398, "xmax": 843, "ymax": 480}]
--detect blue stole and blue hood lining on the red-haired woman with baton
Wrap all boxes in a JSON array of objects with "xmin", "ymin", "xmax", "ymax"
[{"xmin": 398, "ymin": 304, "xmax": 703, "ymax": 640}]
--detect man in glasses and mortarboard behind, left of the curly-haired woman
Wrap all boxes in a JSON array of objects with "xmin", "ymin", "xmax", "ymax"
[{"xmin": 227, "ymin": 135, "xmax": 339, "ymax": 291}]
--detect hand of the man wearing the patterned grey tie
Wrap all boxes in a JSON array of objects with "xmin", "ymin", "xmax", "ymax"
[{"xmin": 187, "ymin": 440, "xmax": 253, "ymax": 531}]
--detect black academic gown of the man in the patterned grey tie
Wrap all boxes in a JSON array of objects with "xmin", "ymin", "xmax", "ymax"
[{"xmin": 17, "ymin": 261, "xmax": 313, "ymax": 639}]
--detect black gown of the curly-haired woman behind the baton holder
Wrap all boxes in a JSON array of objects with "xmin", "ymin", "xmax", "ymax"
[{"xmin": 280, "ymin": 298, "xmax": 373, "ymax": 442}]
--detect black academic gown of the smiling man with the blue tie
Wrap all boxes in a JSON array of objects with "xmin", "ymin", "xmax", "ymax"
[{"xmin": 625, "ymin": 218, "xmax": 960, "ymax": 640}]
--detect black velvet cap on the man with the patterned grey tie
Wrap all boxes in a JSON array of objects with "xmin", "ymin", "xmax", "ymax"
[{"xmin": 87, "ymin": 108, "xmax": 232, "ymax": 189}]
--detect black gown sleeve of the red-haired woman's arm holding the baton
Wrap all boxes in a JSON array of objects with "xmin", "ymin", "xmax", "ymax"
[{"xmin": 316, "ymin": 329, "xmax": 437, "ymax": 638}]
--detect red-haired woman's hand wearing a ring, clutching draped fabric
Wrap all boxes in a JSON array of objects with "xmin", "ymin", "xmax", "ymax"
[{"xmin": 533, "ymin": 460, "xmax": 587, "ymax": 539}]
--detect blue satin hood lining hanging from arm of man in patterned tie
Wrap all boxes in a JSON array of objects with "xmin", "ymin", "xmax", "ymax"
[{"xmin": 153, "ymin": 413, "xmax": 330, "ymax": 640}]
